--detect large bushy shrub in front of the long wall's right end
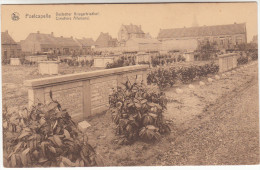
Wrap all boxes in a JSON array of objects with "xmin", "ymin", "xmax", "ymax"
[{"xmin": 108, "ymin": 80, "xmax": 170, "ymax": 144}]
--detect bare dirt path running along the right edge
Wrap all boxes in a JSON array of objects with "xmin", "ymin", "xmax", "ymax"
[{"xmin": 149, "ymin": 62, "xmax": 259, "ymax": 165}]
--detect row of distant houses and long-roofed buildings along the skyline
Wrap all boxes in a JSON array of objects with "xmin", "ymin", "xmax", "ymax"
[{"xmin": 2, "ymin": 23, "xmax": 254, "ymax": 60}]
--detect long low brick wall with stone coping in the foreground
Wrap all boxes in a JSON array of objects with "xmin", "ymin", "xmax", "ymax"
[{"xmin": 24, "ymin": 65, "xmax": 148, "ymax": 120}]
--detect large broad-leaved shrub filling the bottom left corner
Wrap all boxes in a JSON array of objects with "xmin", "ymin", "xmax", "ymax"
[{"xmin": 3, "ymin": 93, "xmax": 102, "ymax": 167}]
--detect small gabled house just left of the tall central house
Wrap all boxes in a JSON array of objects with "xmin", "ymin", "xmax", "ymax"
[{"xmin": 95, "ymin": 32, "xmax": 117, "ymax": 48}]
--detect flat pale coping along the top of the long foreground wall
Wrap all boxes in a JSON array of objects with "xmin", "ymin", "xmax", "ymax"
[{"xmin": 24, "ymin": 65, "xmax": 149, "ymax": 89}]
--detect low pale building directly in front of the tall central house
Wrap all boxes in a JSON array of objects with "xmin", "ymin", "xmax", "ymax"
[{"xmin": 125, "ymin": 38, "xmax": 162, "ymax": 52}]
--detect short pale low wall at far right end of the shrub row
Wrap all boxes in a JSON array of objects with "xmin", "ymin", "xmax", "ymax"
[{"xmin": 218, "ymin": 53, "xmax": 238, "ymax": 72}]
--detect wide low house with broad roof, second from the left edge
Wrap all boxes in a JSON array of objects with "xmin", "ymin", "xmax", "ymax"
[{"xmin": 20, "ymin": 31, "xmax": 81, "ymax": 55}]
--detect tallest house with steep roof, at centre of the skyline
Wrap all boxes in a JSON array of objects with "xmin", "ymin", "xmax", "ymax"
[{"xmin": 118, "ymin": 24, "xmax": 146, "ymax": 45}]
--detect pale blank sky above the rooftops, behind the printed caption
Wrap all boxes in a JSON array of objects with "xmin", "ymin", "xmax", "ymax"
[{"xmin": 1, "ymin": 3, "xmax": 257, "ymax": 41}]
